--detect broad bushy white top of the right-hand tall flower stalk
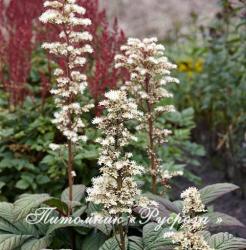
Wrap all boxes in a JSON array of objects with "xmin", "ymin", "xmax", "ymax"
[{"xmin": 115, "ymin": 38, "xmax": 179, "ymax": 105}]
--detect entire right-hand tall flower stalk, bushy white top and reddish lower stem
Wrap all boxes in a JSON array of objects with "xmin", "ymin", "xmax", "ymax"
[{"xmin": 115, "ymin": 38, "xmax": 179, "ymax": 193}]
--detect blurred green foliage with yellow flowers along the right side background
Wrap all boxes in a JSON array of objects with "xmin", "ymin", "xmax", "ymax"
[{"xmin": 167, "ymin": 0, "xmax": 246, "ymax": 191}]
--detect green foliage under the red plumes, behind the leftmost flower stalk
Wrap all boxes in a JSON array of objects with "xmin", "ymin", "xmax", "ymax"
[{"xmin": 0, "ymin": 92, "xmax": 98, "ymax": 200}]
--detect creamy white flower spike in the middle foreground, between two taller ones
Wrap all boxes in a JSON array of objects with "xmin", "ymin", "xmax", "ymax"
[{"xmin": 87, "ymin": 90, "xmax": 152, "ymax": 215}]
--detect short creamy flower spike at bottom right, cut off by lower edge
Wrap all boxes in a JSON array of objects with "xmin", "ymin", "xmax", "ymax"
[{"xmin": 165, "ymin": 187, "xmax": 213, "ymax": 250}]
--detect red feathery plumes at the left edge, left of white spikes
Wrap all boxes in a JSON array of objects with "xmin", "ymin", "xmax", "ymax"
[{"xmin": 0, "ymin": 0, "xmax": 42, "ymax": 105}]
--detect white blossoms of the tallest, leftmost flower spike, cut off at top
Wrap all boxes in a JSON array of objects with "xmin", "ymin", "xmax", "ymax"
[{"xmin": 40, "ymin": 0, "xmax": 93, "ymax": 143}]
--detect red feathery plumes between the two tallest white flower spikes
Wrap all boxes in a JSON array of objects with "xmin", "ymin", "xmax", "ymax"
[{"xmin": 79, "ymin": 0, "xmax": 127, "ymax": 103}]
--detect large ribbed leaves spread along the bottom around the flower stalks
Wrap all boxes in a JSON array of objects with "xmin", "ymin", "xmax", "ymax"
[{"xmin": 0, "ymin": 183, "xmax": 246, "ymax": 250}]
